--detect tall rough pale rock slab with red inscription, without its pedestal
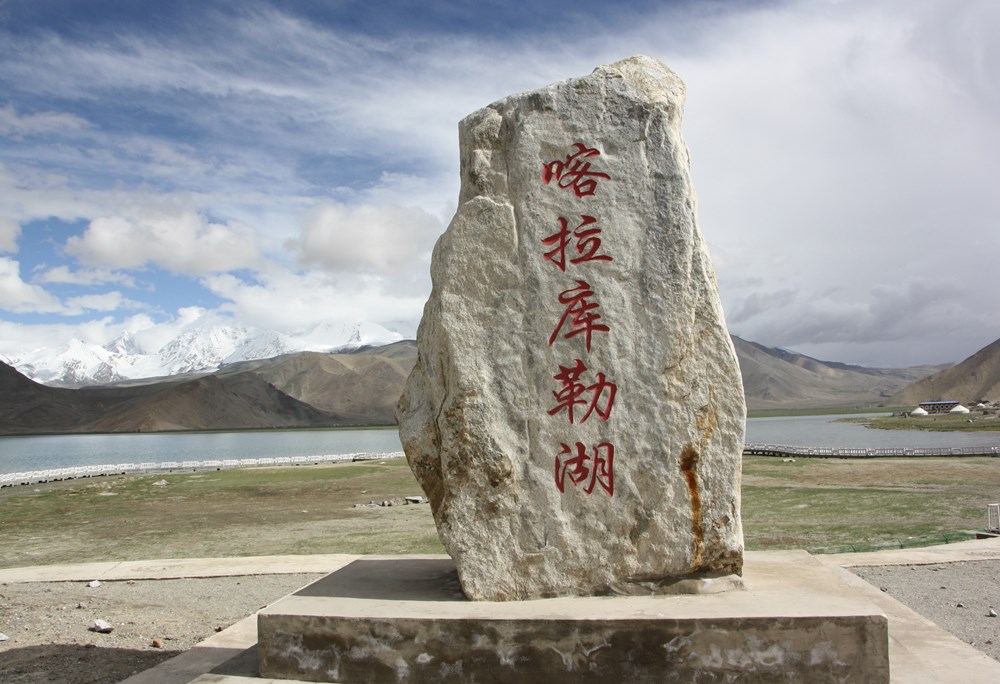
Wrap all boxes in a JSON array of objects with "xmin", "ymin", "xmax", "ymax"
[{"xmin": 398, "ymin": 57, "xmax": 745, "ymax": 600}]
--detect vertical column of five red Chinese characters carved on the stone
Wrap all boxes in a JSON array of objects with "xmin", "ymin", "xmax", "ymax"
[{"xmin": 541, "ymin": 143, "xmax": 618, "ymax": 496}]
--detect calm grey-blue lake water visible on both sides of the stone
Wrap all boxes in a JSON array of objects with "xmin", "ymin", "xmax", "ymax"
[{"xmin": 0, "ymin": 416, "xmax": 1000, "ymax": 474}]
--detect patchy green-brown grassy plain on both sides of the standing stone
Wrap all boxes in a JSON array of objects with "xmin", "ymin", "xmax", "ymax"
[{"xmin": 0, "ymin": 457, "xmax": 1000, "ymax": 567}]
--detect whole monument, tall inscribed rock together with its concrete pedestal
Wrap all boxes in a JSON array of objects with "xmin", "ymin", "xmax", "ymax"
[{"xmin": 257, "ymin": 57, "xmax": 889, "ymax": 684}]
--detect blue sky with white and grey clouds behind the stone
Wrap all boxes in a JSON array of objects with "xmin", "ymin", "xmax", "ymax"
[{"xmin": 0, "ymin": 0, "xmax": 1000, "ymax": 366}]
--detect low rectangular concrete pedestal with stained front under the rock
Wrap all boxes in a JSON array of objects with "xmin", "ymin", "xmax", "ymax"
[{"xmin": 258, "ymin": 551, "xmax": 889, "ymax": 684}]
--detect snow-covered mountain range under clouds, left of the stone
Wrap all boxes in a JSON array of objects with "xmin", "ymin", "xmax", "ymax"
[{"xmin": 10, "ymin": 323, "xmax": 403, "ymax": 387}]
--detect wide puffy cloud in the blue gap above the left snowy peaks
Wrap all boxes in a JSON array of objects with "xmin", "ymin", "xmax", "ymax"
[{"xmin": 66, "ymin": 212, "xmax": 260, "ymax": 274}]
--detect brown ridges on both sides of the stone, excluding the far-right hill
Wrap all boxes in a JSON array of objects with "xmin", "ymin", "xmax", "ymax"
[{"xmin": 0, "ymin": 337, "xmax": 968, "ymax": 434}]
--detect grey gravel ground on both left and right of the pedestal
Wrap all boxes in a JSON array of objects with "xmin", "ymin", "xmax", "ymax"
[{"xmin": 0, "ymin": 560, "xmax": 1000, "ymax": 684}]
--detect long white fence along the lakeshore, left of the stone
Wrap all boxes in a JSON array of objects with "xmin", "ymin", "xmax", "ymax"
[{"xmin": 0, "ymin": 451, "xmax": 403, "ymax": 487}]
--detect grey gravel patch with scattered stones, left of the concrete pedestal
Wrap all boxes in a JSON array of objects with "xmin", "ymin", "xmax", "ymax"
[{"xmin": 0, "ymin": 575, "xmax": 320, "ymax": 684}]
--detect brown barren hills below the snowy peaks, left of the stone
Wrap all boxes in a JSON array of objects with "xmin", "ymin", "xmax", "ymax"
[{"xmin": 0, "ymin": 342, "xmax": 416, "ymax": 434}]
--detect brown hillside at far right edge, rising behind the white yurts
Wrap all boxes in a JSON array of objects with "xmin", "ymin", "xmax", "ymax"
[{"xmin": 895, "ymin": 340, "xmax": 1000, "ymax": 406}]
